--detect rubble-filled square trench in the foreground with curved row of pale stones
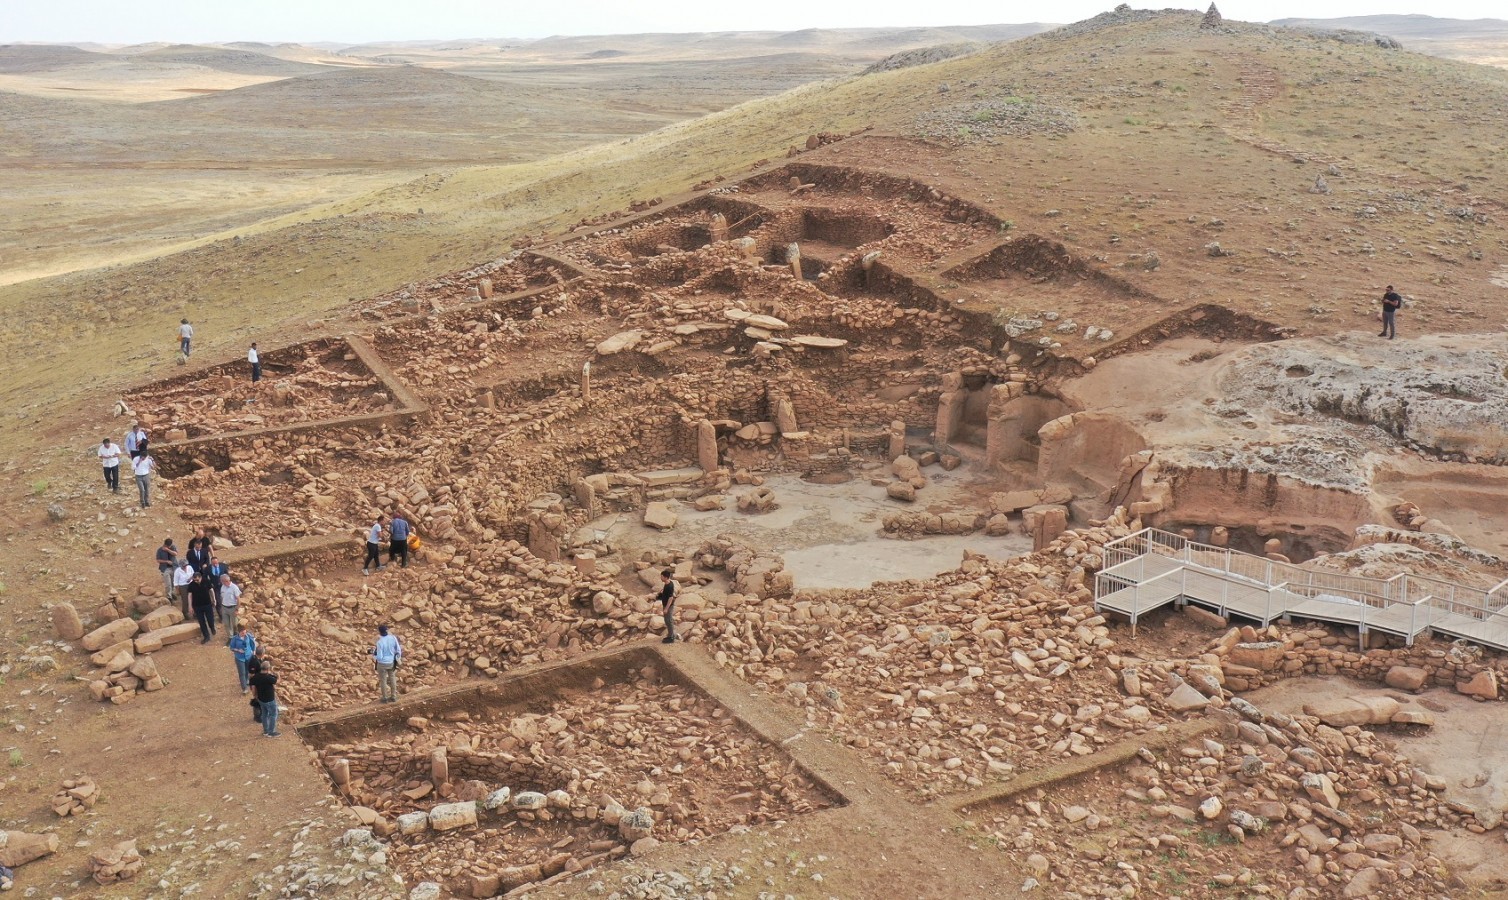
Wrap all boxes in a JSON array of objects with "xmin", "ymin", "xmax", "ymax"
[{"xmin": 320, "ymin": 669, "xmax": 828, "ymax": 897}]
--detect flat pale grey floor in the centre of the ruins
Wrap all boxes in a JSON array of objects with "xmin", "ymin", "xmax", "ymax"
[{"xmin": 593, "ymin": 466, "xmax": 1031, "ymax": 589}]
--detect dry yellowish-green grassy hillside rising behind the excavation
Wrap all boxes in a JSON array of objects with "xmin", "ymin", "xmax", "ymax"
[{"xmin": 0, "ymin": 7, "xmax": 1508, "ymax": 443}]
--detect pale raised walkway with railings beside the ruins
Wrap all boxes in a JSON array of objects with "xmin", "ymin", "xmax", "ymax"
[{"xmin": 1095, "ymin": 528, "xmax": 1508, "ymax": 650}]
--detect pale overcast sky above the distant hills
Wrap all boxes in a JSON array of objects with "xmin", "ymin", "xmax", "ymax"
[{"xmin": 0, "ymin": 0, "xmax": 1508, "ymax": 44}]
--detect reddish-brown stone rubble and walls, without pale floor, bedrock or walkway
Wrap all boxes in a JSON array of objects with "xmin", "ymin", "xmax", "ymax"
[{"xmin": 88, "ymin": 156, "xmax": 1508, "ymax": 897}]
